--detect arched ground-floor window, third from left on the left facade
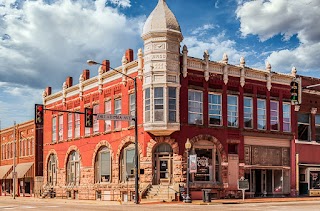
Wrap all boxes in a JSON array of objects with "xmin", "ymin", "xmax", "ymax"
[{"xmin": 95, "ymin": 146, "xmax": 111, "ymax": 183}]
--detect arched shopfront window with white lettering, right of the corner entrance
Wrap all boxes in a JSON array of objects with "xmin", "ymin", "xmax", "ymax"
[{"xmin": 190, "ymin": 140, "xmax": 221, "ymax": 182}]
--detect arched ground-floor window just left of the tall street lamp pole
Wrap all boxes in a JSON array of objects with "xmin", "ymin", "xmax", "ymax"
[{"xmin": 120, "ymin": 144, "xmax": 135, "ymax": 182}]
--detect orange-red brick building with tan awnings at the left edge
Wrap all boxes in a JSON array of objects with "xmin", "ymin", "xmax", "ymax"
[{"xmin": 0, "ymin": 120, "xmax": 43, "ymax": 196}]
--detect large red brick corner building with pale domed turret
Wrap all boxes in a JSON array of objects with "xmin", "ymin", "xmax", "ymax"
[{"xmin": 43, "ymin": 0, "xmax": 296, "ymax": 200}]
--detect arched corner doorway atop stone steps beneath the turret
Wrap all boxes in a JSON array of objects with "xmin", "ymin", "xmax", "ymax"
[{"xmin": 152, "ymin": 143, "xmax": 173, "ymax": 185}]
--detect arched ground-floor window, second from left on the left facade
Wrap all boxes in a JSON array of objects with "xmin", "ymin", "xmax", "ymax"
[{"xmin": 67, "ymin": 151, "xmax": 80, "ymax": 185}]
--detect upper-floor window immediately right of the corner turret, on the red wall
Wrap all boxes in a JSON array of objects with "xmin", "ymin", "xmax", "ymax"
[{"xmin": 188, "ymin": 90, "xmax": 203, "ymax": 125}]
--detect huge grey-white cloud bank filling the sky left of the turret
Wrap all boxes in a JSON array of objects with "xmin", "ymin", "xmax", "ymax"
[{"xmin": 0, "ymin": 0, "xmax": 145, "ymax": 128}]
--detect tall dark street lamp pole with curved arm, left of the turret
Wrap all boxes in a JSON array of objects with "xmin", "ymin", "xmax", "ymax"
[{"xmin": 87, "ymin": 60, "xmax": 139, "ymax": 204}]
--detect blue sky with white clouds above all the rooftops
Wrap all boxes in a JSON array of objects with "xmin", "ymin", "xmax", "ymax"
[{"xmin": 0, "ymin": 0, "xmax": 320, "ymax": 128}]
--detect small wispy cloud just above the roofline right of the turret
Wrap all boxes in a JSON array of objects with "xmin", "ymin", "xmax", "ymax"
[{"xmin": 183, "ymin": 33, "xmax": 249, "ymax": 65}]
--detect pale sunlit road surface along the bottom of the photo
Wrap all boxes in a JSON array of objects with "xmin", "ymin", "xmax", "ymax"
[{"xmin": 0, "ymin": 198, "xmax": 320, "ymax": 211}]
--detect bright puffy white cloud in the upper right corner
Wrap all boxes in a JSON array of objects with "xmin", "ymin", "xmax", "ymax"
[{"xmin": 236, "ymin": 0, "xmax": 320, "ymax": 74}]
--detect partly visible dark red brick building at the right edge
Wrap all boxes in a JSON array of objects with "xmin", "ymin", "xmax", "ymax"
[{"xmin": 295, "ymin": 76, "xmax": 320, "ymax": 196}]
